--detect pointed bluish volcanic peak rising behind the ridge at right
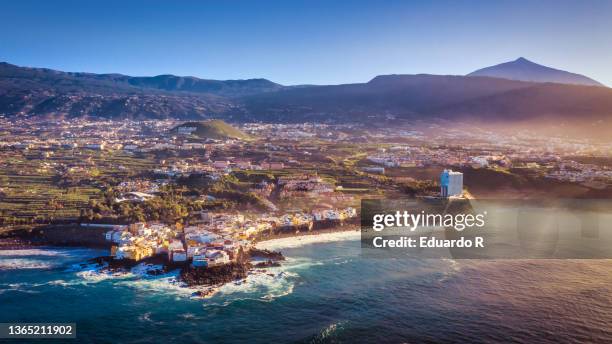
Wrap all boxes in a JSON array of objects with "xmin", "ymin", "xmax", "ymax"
[{"xmin": 468, "ymin": 57, "xmax": 604, "ymax": 86}]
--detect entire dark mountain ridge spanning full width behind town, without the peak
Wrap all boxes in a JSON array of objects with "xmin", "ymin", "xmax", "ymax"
[{"xmin": 0, "ymin": 61, "xmax": 612, "ymax": 134}]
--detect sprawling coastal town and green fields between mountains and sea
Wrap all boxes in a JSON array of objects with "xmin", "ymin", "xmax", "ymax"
[{"xmin": 0, "ymin": 117, "xmax": 612, "ymax": 246}]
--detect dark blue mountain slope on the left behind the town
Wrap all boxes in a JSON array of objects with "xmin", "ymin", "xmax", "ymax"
[{"xmin": 0, "ymin": 62, "xmax": 284, "ymax": 119}]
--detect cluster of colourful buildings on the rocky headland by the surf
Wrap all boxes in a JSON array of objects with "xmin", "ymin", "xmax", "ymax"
[{"xmin": 105, "ymin": 207, "xmax": 357, "ymax": 267}]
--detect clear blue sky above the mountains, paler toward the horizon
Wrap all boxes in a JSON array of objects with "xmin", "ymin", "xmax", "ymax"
[{"xmin": 0, "ymin": 0, "xmax": 612, "ymax": 85}]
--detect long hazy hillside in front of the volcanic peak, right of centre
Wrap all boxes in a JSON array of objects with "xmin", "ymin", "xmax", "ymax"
[{"xmin": 242, "ymin": 75, "xmax": 612, "ymax": 122}]
